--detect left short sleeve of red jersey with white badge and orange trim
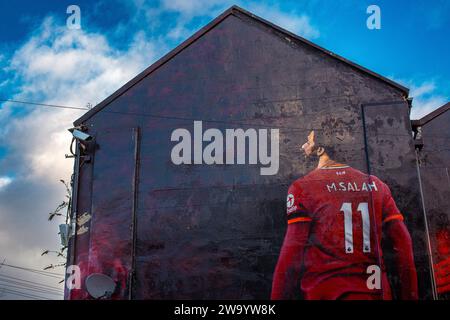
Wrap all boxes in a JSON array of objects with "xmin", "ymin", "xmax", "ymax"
[{"xmin": 286, "ymin": 183, "xmax": 312, "ymax": 224}]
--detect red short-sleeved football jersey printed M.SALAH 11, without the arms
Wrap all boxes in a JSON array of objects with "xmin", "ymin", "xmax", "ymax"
[{"xmin": 287, "ymin": 165, "xmax": 403, "ymax": 299}]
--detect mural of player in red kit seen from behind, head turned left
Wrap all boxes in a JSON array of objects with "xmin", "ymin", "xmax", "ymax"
[{"xmin": 271, "ymin": 131, "xmax": 418, "ymax": 300}]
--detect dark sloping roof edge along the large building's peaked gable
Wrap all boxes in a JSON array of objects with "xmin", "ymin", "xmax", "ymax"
[{"xmin": 73, "ymin": 5, "xmax": 409, "ymax": 126}]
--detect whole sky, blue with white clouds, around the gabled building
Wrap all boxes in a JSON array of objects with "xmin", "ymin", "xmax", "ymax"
[{"xmin": 0, "ymin": 0, "xmax": 450, "ymax": 299}]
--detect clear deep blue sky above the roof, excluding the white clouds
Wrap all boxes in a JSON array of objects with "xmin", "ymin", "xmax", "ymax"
[{"xmin": 0, "ymin": 0, "xmax": 450, "ymax": 101}]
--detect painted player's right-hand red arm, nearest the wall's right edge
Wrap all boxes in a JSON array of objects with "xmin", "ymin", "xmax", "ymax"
[{"xmin": 383, "ymin": 219, "xmax": 418, "ymax": 300}]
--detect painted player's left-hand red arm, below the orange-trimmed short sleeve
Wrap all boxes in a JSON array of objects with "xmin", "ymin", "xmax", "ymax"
[{"xmin": 270, "ymin": 221, "xmax": 310, "ymax": 300}]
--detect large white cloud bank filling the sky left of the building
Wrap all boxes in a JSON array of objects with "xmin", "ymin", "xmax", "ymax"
[{"xmin": 0, "ymin": 18, "xmax": 160, "ymax": 300}]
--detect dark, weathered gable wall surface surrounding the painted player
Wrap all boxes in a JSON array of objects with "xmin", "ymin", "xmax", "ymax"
[{"xmin": 66, "ymin": 14, "xmax": 431, "ymax": 299}]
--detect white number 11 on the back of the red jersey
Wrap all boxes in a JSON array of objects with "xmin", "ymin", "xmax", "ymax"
[{"xmin": 341, "ymin": 202, "xmax": 370, "ymax": 253}]
